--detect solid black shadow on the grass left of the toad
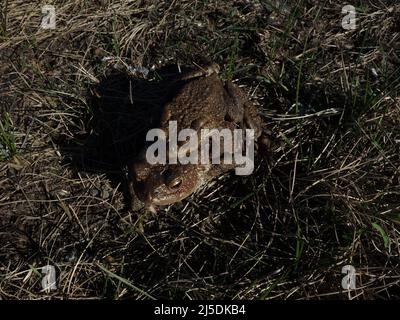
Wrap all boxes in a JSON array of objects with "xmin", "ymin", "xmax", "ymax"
[{"xmin": 59, "ymin": 65, "xmax": 198, "ymax": 205}]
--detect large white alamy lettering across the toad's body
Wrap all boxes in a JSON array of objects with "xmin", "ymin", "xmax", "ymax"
[{"xmin": 146, "ymin": 121, "xmax": 254, "ymax": 175}]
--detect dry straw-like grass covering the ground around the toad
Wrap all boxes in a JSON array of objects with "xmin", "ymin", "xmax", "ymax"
[{"xmin": 0, "ymin": 0, "xmax": 400, "ymax": 299}]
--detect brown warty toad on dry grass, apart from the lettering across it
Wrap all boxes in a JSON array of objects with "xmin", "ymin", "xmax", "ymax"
[{"xmin": 129, "ymin": 64, "xmax": 262, "ymax": 212}]
